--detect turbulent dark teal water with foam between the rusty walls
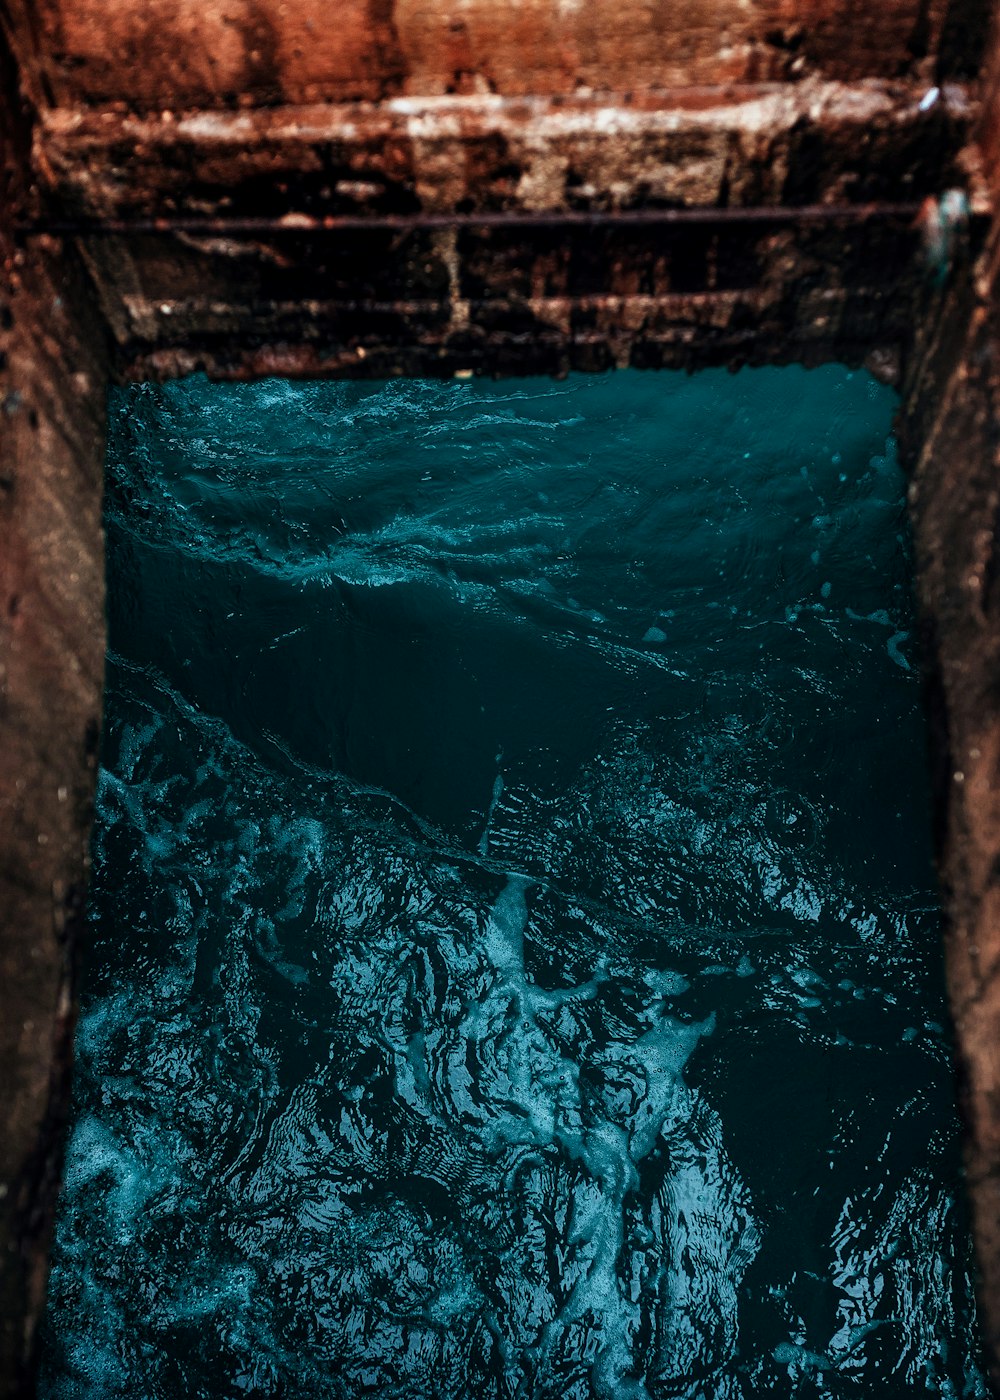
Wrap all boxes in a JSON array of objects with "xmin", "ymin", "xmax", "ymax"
[{"xmin": 42, "ymin": 368, "xmax": 985, "ymax": 1400}]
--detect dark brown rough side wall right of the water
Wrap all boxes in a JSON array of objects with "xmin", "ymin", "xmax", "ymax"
[{"xmin": 901, "ymin": 21, "xmax": 1000, "ymax": 1393}]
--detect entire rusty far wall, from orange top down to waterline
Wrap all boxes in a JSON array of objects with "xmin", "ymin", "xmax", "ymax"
[{"xmin": 19, "ymin": 0, "xmax": 989, "ymax": 378}]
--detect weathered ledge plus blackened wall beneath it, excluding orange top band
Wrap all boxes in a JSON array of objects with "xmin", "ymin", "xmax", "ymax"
[{"xmin": 36, "ymin": 81, "xmax": 973, "ymax": 389}]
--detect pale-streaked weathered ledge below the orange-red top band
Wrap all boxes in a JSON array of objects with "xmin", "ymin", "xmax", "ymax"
[{"xmin": 35, "ymin": 78, "xmax": 976, "ymax": 220}]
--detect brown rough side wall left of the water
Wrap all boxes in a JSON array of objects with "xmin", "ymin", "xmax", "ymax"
[{"xmin": 0, "ymin": 21, "xmax": 108, "ymax": 1400}]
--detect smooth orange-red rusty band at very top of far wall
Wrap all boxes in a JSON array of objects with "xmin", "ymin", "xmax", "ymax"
[{"xmin": 18, "ymin": 0, "xmax": 986, "ymax": 111}]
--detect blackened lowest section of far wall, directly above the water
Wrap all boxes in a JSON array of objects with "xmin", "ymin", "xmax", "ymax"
[{"xmin": 87, "ymin": 211, "xmax": 919, "ymax": 378}]
